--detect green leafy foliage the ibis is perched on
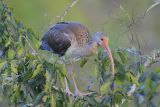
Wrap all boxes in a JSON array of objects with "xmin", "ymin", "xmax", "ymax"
[{"xmin": 0, "ymin": 1, "xmax": 160, "ymax": 107}]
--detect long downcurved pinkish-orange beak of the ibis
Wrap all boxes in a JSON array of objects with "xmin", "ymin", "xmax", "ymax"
[{"xmin": 101, "ymin": 39, "xmax": 114, "ymax": 77}]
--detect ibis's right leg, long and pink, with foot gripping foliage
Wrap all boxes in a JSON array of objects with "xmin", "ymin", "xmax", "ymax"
[{"xmin": 68, "ymin": 65, "xmax": 92, "ymax": 97}]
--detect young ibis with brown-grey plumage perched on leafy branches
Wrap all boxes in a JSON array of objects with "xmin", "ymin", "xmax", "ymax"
[{"xmin": 41, "ymin": 22, "xmax": 114, "ymax": 96}]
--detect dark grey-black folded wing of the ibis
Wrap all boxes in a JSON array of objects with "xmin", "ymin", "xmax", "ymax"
[{"xmin": 41, "ymin": 25, "xmax": 71, "ymax": 56}]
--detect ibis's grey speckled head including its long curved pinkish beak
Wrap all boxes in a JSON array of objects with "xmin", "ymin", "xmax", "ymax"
[{"xmin": 93, "ymin": 32, "xmax": 114, "ymax": 77}]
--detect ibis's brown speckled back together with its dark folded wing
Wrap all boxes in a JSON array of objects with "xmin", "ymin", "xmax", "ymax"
[{"xmin": 41, "ymin": 22, "xmax": 89, "ymax": 56}]
